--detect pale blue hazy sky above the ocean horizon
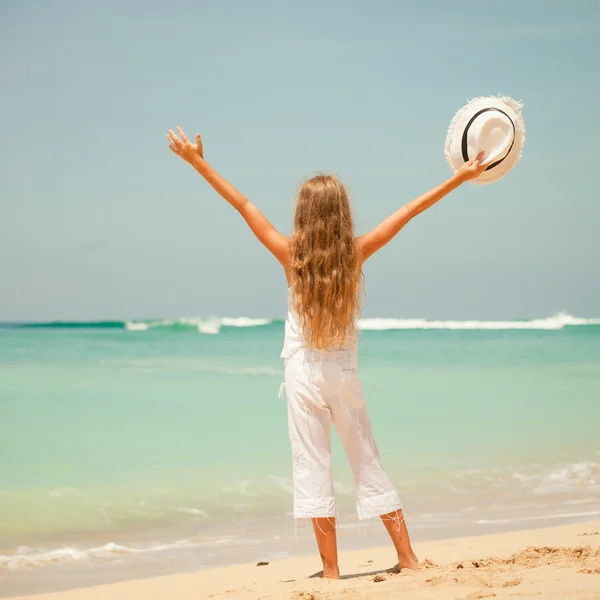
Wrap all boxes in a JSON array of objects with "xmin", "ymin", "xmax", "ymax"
[{"xmin": 0, "ymin": 0, "xmax": 600, "ymax": 321}]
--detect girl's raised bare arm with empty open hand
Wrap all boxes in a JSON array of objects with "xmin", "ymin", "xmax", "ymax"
[{"xmin": 167, "ymin": 127, "xmax": 289, "ymax": 270}]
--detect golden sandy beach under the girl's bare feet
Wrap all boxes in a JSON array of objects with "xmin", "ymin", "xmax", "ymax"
[{"xmin": 10, "ymin": 521, "xmax": 600, "ymax": 600}]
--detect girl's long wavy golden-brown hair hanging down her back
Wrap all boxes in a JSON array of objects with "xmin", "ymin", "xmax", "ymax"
[{"xmin": 290, "ymin": 175, "xmax": 362, "ymax": 350}]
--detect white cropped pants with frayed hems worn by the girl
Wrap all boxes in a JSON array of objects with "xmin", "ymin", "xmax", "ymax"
[{"xmin": 285, "ymin": 350, "xmax": 402, "ymax": 519}]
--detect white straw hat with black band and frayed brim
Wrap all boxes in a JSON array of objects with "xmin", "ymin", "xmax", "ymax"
[{"xmin": 445, "ymin": 96, "xmax": 525, "ymax": 184}]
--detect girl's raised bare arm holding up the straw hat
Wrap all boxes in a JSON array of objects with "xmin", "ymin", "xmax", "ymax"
[{"xmin": 357, "ymin": 153, "xmax": 487, "ymax": 262}]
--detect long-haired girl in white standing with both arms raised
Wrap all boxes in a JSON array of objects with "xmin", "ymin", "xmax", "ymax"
[{"xmin": 167, "ymin": 127, "xmax": 486, "ymax": 579}]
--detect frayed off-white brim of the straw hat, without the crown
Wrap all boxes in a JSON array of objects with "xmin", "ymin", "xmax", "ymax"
[{"xmin": 444, "ymin": 96, "xmax": 525, "ymax": 185}]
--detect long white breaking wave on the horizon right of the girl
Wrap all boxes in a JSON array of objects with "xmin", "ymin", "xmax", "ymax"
[{"xmin": 359, "ymin": 312, "xmax": 600, "ymax": 331}]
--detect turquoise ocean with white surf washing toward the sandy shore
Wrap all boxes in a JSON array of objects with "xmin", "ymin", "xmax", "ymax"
[{"xmin": 0, "ymin": 314, "xmax": 600, "ymax": 597}]
